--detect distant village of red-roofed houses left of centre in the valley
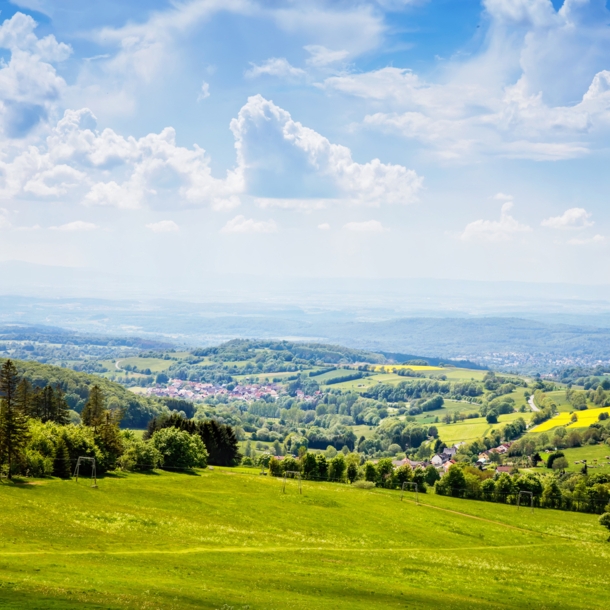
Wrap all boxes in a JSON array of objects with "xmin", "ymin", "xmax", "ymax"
[{"xmin": 146, "ymin": 379, "xmax": 281, "ymax": 402}]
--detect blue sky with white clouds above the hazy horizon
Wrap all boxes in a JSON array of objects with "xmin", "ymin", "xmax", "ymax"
[{"xmin": 0, "ymin": 0, "xmax": 610, "ymax": 284}]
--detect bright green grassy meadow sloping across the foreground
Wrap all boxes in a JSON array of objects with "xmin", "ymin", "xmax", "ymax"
[{"xmin": 0, "ymin": 469, "xmax": 610, "ymax": 610}]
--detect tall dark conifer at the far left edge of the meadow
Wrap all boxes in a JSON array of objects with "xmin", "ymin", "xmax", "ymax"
[{"xmin": 0, "ymin": 360, "xmax": 27, "ymax": 479}]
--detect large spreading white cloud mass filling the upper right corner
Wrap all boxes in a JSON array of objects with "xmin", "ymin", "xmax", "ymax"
[{"xmin": 324, "ymin": 0, "xmax": 610, "ymax": 161}]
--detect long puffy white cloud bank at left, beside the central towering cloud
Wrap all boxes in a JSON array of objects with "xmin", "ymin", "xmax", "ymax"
[{"xmin": 0, "ymin": 108, "xmax": 243, "ymax": 209}]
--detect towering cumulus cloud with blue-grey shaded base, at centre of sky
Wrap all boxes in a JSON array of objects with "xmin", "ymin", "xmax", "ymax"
[{"xmin": 231, "ymin": 95, "xmax": 423, "ymax": 205}]
